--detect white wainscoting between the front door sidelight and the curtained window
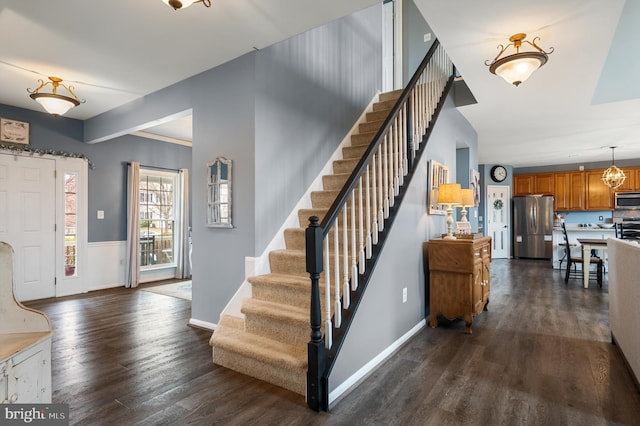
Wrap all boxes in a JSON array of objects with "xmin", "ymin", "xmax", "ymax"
[{"xmin": 85, "ymin": 241, "xmax": 127, "ymax": 291}]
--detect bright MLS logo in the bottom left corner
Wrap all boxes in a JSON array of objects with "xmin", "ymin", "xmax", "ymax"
[{"xmin": 0, "ymin": 404, "xmax": 69, "ymax": 426}]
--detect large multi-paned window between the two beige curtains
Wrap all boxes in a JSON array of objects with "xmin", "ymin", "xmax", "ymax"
[{"xmin": 139, "ymin": 169, "xmax": 179, "ymax": 270}]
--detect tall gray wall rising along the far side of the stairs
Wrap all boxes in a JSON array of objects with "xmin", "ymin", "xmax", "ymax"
[{"xmin": 255, "ymin": 6, "xmax": 382, "ymax": 254}]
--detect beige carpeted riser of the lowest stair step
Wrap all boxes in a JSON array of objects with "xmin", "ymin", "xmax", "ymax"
[{"xmin": 213, "ymin": 347, "xmax": 307, "ymax": 395}]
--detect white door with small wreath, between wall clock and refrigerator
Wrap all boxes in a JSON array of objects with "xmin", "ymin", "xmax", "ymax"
[{"xmin": 486, "ymin": 185, "xmax": 511, "ymax": 259}]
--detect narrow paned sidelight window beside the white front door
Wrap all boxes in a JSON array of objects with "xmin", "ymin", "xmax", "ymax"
[{"xmin": 64, "ymin": 173, "xmax": 78, "ymax": 277}]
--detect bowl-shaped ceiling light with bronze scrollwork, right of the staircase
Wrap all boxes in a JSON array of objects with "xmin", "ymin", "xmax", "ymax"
[{"xmin": 484, "ymin": 33, "xmax": 553, "ymax": 87}]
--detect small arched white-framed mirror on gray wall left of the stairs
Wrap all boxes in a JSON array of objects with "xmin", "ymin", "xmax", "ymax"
[{"xmin": 207, "ymin": 157, "xmax": 233, "ymax": 228}]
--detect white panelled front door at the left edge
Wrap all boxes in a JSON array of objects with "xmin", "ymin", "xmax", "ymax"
[{"xmin": 0, "ymin": 154, "xmax": 56, "ymax": 301}]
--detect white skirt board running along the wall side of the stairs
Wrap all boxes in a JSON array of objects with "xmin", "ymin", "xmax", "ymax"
[{"xmin": 214, "ymin": 92, "xmax": 380, "ymax": 322}]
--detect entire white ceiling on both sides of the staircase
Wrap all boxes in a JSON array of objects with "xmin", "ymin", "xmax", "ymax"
[{"xmin": 0, "ymin": 0, "xmax": 640, "ymax": 167}]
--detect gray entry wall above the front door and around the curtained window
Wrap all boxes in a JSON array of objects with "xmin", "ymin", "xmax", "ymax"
[{"xmin": 0, "ymin": 104, "xmax": 191, "ymax": 242}]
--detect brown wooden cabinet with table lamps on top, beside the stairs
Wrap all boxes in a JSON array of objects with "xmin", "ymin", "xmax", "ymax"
[{"xmin": 427, "ymin": 237, "xmax": 491, "ymax": 334}]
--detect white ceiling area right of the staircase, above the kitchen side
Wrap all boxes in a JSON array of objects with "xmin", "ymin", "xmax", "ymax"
[{"xmin": 415, "ymin": 0, "xmax": 640, "ymax": 167}]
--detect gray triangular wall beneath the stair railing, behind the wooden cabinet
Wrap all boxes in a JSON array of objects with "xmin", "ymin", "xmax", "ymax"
[{"xmin": 329, "ymin": 90, "xmax": 478, "ymax": 391}]
